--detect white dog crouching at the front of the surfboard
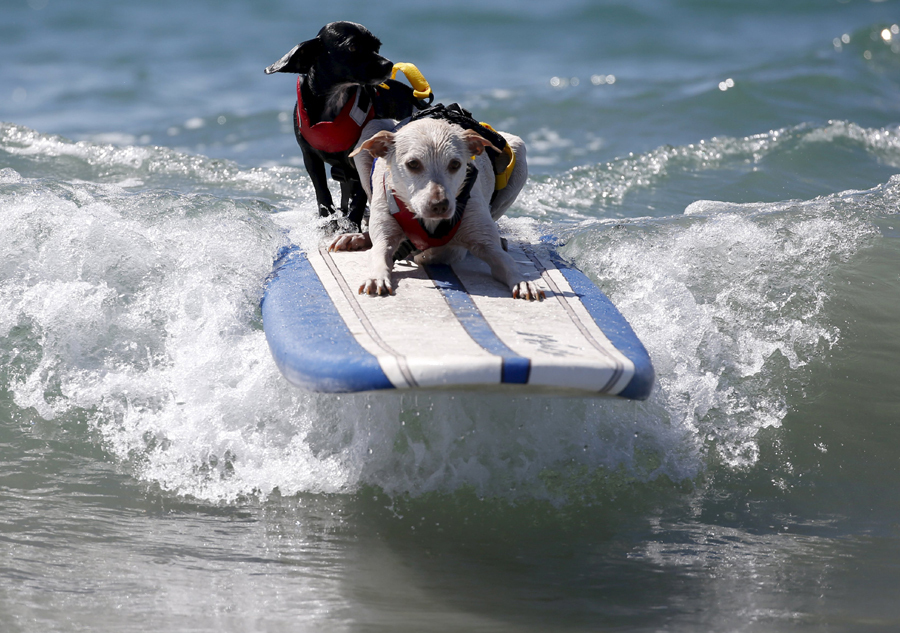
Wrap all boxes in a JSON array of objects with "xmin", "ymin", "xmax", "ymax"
[{"xmin": 331, "ymin": 119, "xmax": 544, "ymax": 301}]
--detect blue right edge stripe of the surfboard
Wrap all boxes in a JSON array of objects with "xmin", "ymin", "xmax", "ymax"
[{"xmin": 550, "ymin": 251, "xmax": 656, "ymax": 400}]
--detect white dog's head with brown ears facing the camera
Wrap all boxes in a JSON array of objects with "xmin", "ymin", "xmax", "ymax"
[{"xmin": 352, "ymin": 119, "xmax": 490, "ymax": 222}]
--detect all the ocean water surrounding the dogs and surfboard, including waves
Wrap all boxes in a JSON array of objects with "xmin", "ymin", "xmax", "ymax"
[{"xmin": 0, "ymin": 0, "xmax": 900, "ymax": 633}]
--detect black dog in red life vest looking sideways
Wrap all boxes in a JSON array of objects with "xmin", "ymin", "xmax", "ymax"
[{"xmin": 266, "ymin": 22, "xmax": 428, "ymax": 228}]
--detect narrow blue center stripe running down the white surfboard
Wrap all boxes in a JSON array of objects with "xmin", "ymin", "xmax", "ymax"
[{"xmin": 426, "ymin": 264, "xmax": 531, "ymax": 385}]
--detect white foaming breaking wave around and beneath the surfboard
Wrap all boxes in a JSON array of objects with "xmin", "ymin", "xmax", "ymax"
[{"xmin": 0, "ymin": 122, "xmax": 900, "ymax": 502}]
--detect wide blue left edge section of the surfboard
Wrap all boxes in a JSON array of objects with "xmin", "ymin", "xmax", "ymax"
[{"xmin": 262, "ymin": 245, "xmax": 394, "ymax": 392}]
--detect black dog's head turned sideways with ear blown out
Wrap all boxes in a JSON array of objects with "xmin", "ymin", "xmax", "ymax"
[{"xmin": 266, "ymin": 22, "xmax": 393, "ymax": 94}]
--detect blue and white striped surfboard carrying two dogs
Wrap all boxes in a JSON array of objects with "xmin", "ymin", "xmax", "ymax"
[{"xmin": 262, "ymin": 242, "xmax": 654, "ymax": 400}]
